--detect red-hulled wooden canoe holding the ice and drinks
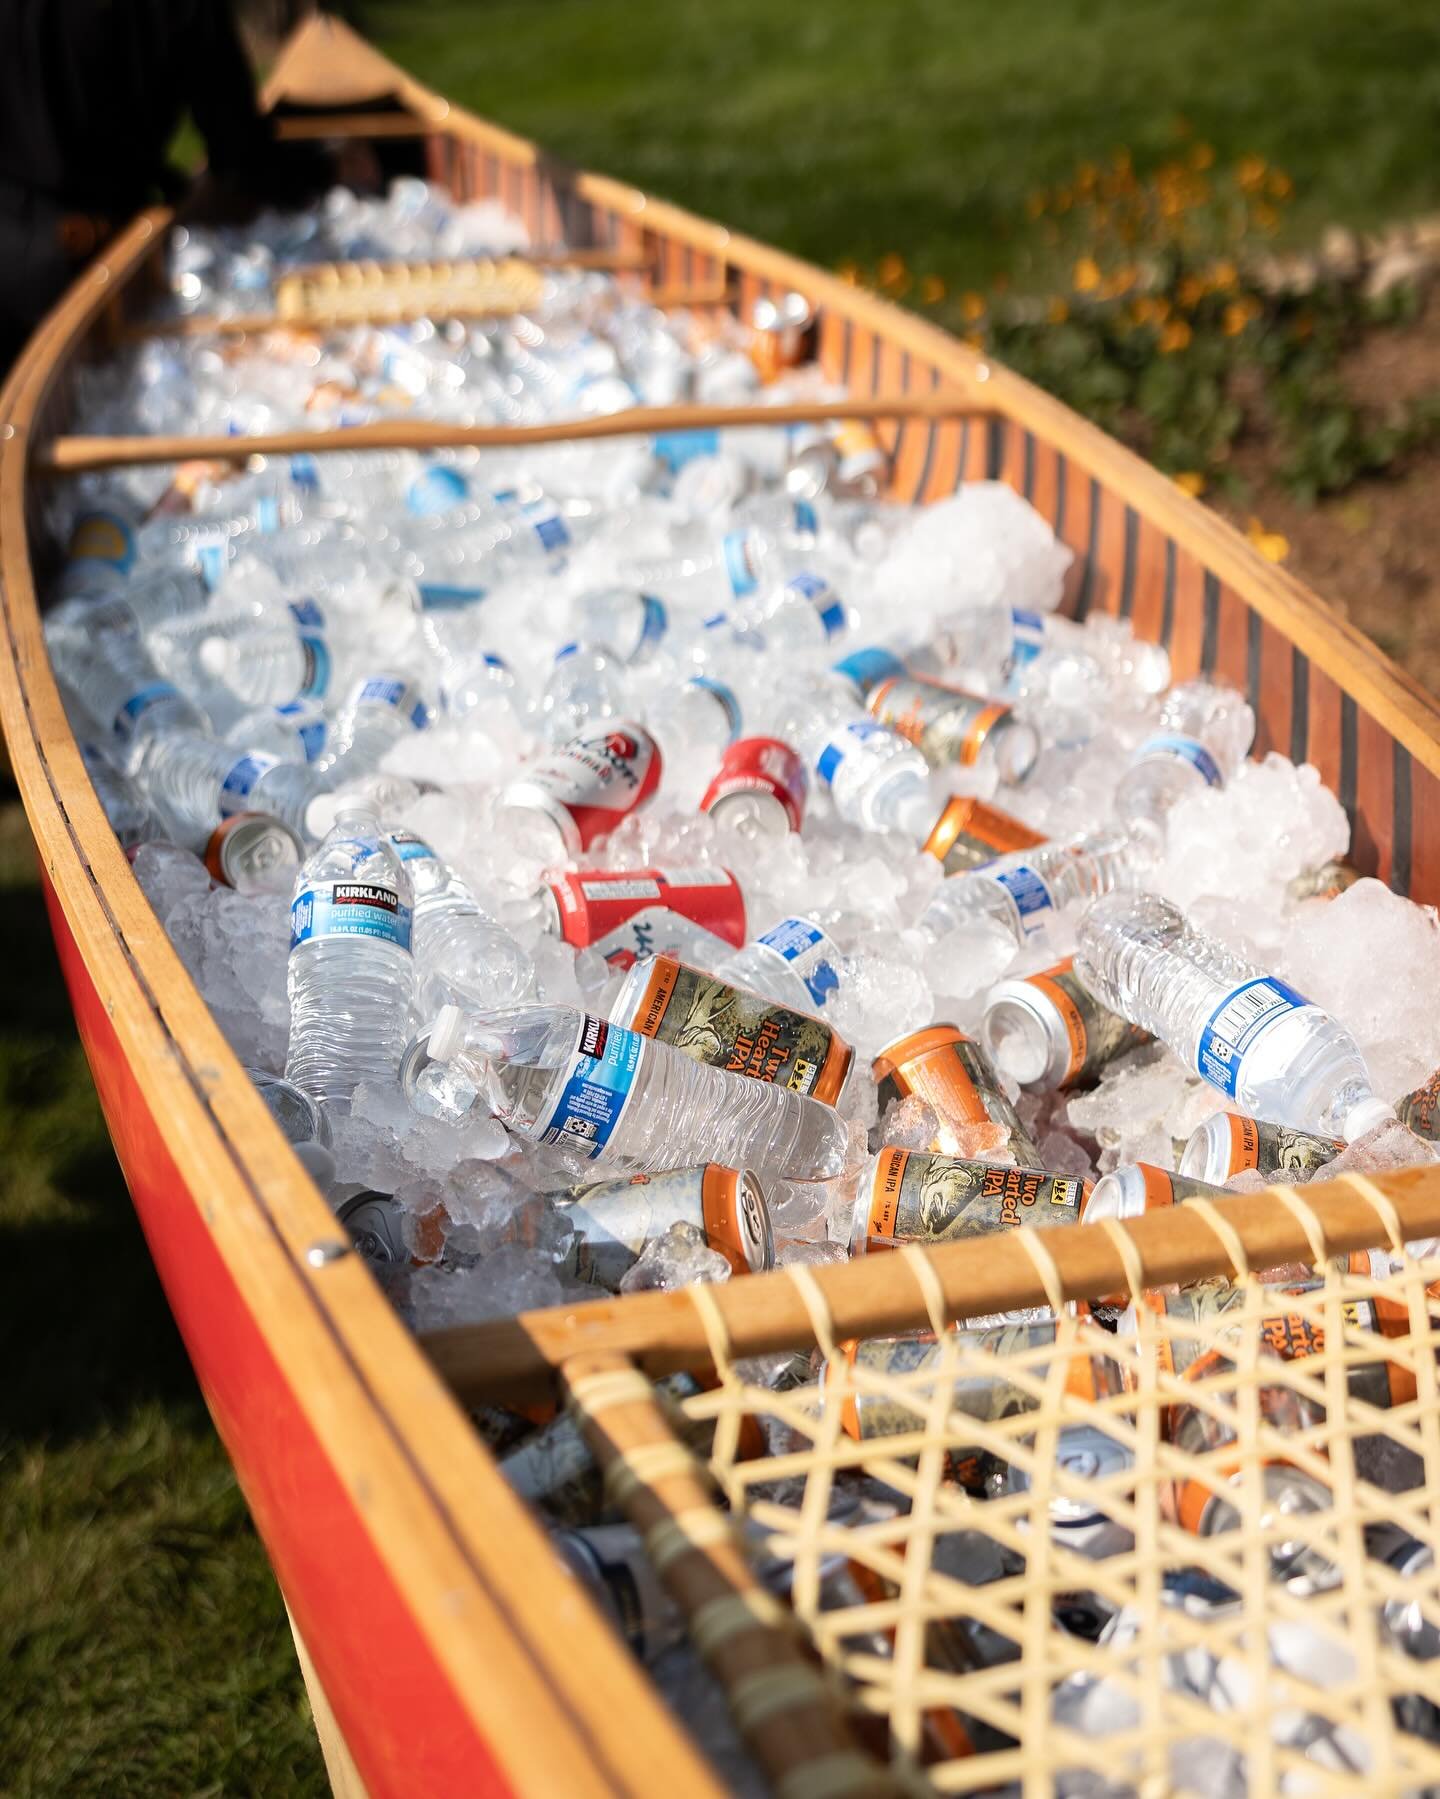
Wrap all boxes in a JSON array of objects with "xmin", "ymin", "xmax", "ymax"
[{"xmin": 0, "ymin": 18, "xmax": 1440, "ymax": 1799}]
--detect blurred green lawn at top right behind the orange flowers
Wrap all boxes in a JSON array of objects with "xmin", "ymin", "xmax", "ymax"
[{"xmin": 360, "ymin": 0, "xmax": 1440, "ymax": 288}]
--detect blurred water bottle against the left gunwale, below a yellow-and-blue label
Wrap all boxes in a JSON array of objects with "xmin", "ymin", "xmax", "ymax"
[{"xmin": 47, "ymin": 603, "xmax": 209, "ymax": 774}]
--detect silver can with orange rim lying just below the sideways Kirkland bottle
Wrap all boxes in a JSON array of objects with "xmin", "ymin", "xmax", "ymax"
[{"xmin": 558, "ymin": 1162, "xmax": 776, "ymax": 1293}]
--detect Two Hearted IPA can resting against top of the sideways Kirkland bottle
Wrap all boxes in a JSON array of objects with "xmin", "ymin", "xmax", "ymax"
[{"xmin": 610, "ymin": 955, "xmax": 855, "ymax": 1106}]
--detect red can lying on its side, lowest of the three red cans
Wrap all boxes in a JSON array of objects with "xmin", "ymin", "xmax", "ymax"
[{"xmin": 540, "ymin": 869, "xmax": 745, "ymax": 968}]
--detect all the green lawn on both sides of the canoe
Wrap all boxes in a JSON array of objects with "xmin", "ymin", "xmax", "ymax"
[{"xmin": 0, "ymin": 0, "xmax": 1440, "ymax": 1795}]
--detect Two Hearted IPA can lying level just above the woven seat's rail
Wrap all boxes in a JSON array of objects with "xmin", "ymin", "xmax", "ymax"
[{"xmin": 850, "ymin": 1148, "xmax": 1091, "ymax": 1256}]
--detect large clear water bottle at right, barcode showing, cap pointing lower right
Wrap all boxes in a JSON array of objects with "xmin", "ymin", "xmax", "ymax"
[{"xmin": 1075, "ymin": 892, "xmax": 1395, "ymax": 1142}]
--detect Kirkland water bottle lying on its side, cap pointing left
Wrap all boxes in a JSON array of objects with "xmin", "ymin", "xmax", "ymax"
[{"xmin": 403, "ymin": 1006, "xmax": 848, "ymax": 1180}]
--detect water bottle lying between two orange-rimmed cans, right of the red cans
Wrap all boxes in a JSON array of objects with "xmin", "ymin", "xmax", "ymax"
[{"xmin": 918, "ymin": 828, "xmax": 1138, "ymax": 955}]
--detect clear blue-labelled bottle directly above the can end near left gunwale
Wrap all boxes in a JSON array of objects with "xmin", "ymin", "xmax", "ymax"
[{"xmin": 139, "ymin": 732, "xmax": 328, "ymax": 849}]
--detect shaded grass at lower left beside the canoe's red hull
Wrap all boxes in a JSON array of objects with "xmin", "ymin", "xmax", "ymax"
[{"xmin": 0, "ymin": 793, "xmax": 324, "ymax": 1799}]
